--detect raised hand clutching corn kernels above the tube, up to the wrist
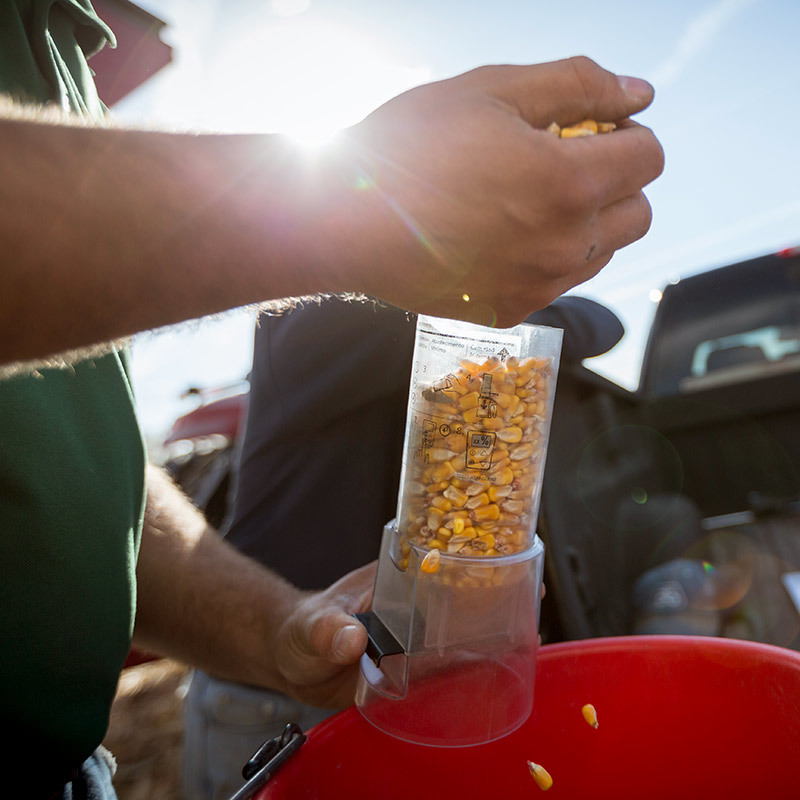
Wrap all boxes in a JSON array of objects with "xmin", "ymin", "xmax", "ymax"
[{"xmin": 328, "ymin": 58, "xmax": 663, "ymax": 326}]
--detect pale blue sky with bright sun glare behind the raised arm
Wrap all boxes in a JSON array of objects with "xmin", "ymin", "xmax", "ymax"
[{"xmin": 116, "ymin": 0, "xmax": 800, "ymax": 435}]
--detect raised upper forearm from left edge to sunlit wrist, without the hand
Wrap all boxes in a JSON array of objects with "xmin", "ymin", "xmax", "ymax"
[{"xmin": 0, "ymin": 108, "xmax": 357, "ymax": 363}]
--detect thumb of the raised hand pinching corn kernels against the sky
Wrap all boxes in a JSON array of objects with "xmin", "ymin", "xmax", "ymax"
[{"xmin": 495, "ymin": 56, "xmax": 654, "ymax": 128}]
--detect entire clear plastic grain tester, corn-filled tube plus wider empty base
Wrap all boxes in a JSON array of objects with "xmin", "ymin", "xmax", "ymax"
[{"xmin": 356, "ymin": 317, "xmax": 562, "ymax": 747}]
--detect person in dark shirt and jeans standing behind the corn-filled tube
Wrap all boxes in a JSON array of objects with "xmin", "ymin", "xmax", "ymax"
[{"xmin": 184, "ymin": 296, "xmax": 623, "ymax": 800}]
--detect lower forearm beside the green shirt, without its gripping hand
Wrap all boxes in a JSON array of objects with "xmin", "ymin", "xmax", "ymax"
[{"xmin": 134, "ymin": 468, "xmax": 305, "ymax": 690}]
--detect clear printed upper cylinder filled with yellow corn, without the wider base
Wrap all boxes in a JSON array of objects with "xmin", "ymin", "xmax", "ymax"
[{"xmin": 397, "ymin": 316, "xmax": 562, "ymax": 571}]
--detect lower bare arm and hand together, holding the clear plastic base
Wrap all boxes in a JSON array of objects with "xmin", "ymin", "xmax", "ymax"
[{"xmin": 134, "ymin": 468, "xmax": 375, "ymax": 708}]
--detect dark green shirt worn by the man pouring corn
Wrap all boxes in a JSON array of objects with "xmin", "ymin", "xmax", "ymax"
[{"xmin": 0, "ymin": 0, "xmax": 145, "ymax": 797}]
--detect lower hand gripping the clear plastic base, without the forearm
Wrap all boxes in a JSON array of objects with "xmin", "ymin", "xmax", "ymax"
[{"xmin": 275, "ymin": 563, "xmax": 376, "ymax": 708}]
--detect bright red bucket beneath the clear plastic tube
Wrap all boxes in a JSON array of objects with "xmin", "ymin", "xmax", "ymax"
[{"xmin": 257, "ymin": 636, "xmax": 800, "ymax": 800}]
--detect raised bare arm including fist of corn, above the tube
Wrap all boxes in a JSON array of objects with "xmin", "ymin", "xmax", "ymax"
[{"xmin": 0, "ymin": 59, "xmax": 663, "ymax": 363}]
